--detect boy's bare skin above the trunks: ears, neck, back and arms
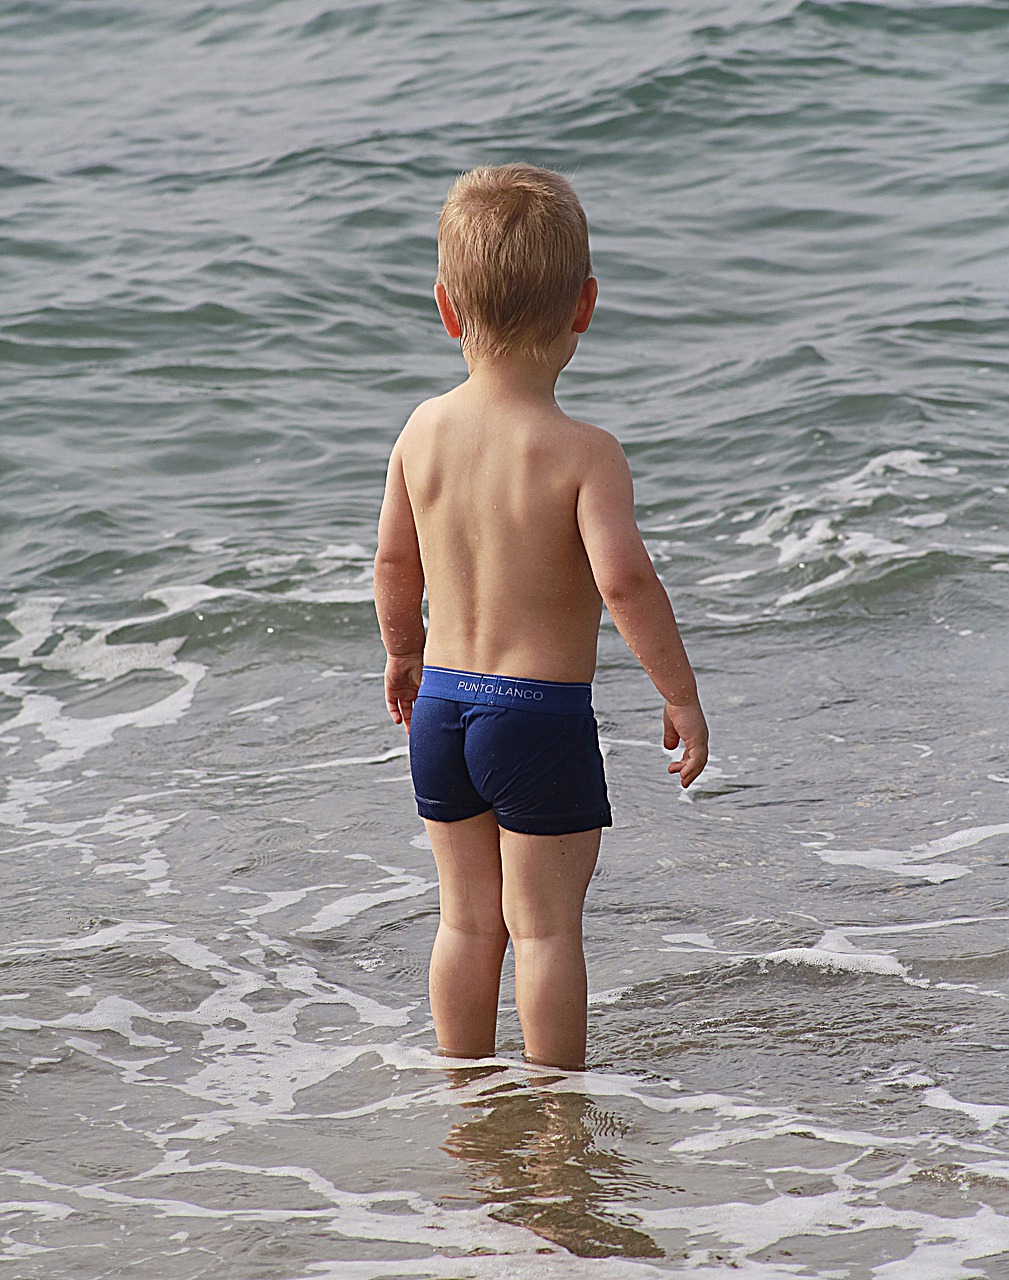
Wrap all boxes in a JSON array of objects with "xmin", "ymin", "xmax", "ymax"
[{"xmin": 375, "ymin": 279, "xmax": 707, "ymax": 786}]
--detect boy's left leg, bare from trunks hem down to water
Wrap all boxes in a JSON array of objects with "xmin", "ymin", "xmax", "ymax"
[{"xmin": 424, "ymin": 813, "xmax": 508, "ymax": 1057}]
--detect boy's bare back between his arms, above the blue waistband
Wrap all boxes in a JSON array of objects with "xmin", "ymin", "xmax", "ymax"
[{"xmin": 398, "ymin": 384, "xmax": 609, "ymax": 681}]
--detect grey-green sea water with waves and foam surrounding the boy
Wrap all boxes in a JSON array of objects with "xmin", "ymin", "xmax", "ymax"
[{"xmin": 0, "ymin": 0, "xmax": 1009, "ymax": 1280}]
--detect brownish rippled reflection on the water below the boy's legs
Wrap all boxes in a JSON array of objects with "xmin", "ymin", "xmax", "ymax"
[{"xmin": 443, "ymin": 1068, "xmax": 665, "ymax": 1258}]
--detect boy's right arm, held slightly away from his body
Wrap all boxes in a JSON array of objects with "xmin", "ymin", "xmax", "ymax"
[{"xmin": 577, "ymin": 433, "xmax": 708, "ymax": 787}]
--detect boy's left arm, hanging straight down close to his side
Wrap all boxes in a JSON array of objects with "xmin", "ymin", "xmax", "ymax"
[{"xmin": 375, "ymin": 442, "xmax": 425, "ymax": 733}]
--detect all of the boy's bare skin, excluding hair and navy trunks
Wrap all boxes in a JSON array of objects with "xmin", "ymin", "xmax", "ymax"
[{"xmin": 375, "ymin": 172, "xmax": 708, "ymax": 1070}]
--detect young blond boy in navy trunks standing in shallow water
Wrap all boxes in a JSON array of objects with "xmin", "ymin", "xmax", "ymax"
[{"xmin": 375, "ymin": 164, "xmax": 708, "ymax": 1070}]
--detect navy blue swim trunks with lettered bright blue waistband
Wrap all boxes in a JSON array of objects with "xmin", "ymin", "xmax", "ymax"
[{"xmin": 410, "ymin": 667, "xmax": 613, "ymax": 836}]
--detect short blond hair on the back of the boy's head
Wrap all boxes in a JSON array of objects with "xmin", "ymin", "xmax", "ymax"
[{"xmin": 438, "ymin": 164, "xmax": 592, "ymax": 356}]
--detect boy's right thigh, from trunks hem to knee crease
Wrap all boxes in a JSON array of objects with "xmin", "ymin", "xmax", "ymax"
[{"xmin": 501, "ymin": 827, "xmax": 602, "ymax": 940}]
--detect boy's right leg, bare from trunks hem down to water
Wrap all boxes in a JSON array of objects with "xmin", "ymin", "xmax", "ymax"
[{"xmin": 501, "ymin": 827, "xmax": 602, "ymax": 1070}]
